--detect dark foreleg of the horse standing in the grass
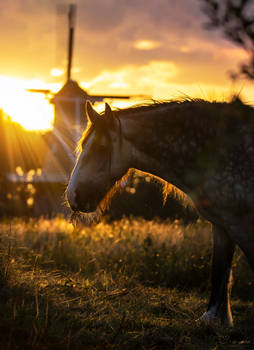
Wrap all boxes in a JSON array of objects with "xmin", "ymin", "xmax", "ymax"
[{"xmin": 199, "ymin": 225, "xmax": 235, "ymax": 326}]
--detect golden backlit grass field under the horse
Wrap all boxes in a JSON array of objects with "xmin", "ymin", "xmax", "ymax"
[{"xmin": 0, "ymin": 218, "xmax": 254, "ymax": 350}]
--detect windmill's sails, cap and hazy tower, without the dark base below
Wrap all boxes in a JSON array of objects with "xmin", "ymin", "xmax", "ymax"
[{"xmin": 33, "ymin": 4, "xmax": 135, "ymax": 183}]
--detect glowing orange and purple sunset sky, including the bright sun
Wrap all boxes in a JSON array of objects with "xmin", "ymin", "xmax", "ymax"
[{"xmin": 0, "ymin": 0, "xmax": 254, "ymax": 129}]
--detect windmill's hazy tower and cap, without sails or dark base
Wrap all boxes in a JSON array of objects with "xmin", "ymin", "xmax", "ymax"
[{"xmin": 42, "ymin": 80, "xmax": 90, "ymax": 183}]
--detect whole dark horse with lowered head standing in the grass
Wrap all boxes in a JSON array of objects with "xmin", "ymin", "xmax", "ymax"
[{"xmin": 67, "ymin": 98, "xmax": 254, "ymax": 326}]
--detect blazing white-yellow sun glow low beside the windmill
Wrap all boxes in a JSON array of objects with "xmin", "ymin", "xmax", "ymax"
[{"xmin": 0, "ymin": 76, "xmax": 57, "ymax": 131}]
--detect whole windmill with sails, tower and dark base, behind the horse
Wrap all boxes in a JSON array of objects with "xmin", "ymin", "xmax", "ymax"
[{"xmin": 28, "ymin": 4, "xmax": 148, "ymax": 214}]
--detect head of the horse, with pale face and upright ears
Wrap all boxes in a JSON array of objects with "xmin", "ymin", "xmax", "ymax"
[{"xmin": 67, "ymin": 102, "xmax": 130, "ymax": 213}]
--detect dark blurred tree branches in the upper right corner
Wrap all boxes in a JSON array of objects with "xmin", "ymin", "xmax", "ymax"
[{"xmin": 200, "ymin": 0, "xmax": 254, "ymax": 79}]
